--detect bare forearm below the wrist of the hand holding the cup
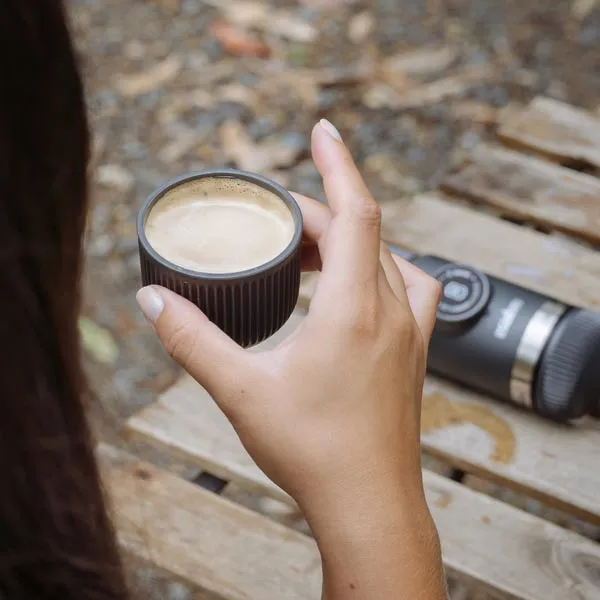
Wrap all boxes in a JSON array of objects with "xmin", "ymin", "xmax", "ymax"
[{"xmin": 308, "ymin": 476, "xmax": 447, "ymax": 600}]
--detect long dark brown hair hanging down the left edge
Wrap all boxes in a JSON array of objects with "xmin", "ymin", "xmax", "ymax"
[{"xmin": 0, "ymin": 0, "xmax": 127, "ymax": 600}]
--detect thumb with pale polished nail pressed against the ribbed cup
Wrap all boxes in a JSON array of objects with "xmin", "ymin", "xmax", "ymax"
[{"xmin": 136, "ymin": 285, "xmax": 248, "ymax": 408}]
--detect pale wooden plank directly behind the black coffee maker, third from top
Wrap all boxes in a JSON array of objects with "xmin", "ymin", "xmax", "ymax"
[{"xmin": 383, "ymin": 194, "xmax": 600, "ymax": 307}]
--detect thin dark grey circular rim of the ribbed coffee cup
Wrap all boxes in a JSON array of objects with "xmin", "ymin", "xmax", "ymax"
[{"xmin": 137, "ymin": 169, "xmax": 303, "ymax": 281}]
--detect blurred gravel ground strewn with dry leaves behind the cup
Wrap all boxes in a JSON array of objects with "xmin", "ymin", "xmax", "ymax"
[{"xmin": 73, "ymin": 0, "xmax": 600, "ymax": 598}]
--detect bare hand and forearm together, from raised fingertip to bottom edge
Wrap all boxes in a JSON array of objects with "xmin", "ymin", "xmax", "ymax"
[{"xmin": 138, "ymin": 124, "xmax": 447, "ymax": 600}]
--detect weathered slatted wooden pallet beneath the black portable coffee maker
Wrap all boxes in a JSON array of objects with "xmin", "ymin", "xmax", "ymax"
[{"xmin": 100, "ymin": 98, "xmax": 600, "ymax": 600}]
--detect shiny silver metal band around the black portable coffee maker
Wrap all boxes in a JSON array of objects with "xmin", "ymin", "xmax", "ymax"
[{"xmin": 510, "ymin": 302, "xmax": 567, "ymax": 408}]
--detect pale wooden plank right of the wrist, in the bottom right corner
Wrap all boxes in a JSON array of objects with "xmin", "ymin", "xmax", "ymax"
[{"xmin": 424, "ymin": 471, "xmax": 600, "ymax": 600}]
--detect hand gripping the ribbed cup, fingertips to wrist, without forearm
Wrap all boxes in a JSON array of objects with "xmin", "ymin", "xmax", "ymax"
[{"xmin": 139, "ymin": 125, "xmax": 439, "ymax": 502}]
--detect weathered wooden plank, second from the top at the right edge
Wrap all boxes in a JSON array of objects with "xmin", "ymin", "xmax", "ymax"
[{"xmin": 442, "ymin": 144, "xmax": 600, "ymax": 242}]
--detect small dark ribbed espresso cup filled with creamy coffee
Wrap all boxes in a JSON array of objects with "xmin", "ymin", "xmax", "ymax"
[{"xmin": 137, "ymin": 169, "xmax": 302, "ymax": 347}]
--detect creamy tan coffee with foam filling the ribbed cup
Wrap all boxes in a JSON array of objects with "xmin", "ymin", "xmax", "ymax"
[{"xmin": 144, "ymin": 177, "xmax": 295, "ymax": 273}]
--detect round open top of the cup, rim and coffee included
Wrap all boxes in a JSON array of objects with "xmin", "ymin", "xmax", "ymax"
[{"xmin": 137, "ymin": 169, "xmax": 302, "ymax": 280}]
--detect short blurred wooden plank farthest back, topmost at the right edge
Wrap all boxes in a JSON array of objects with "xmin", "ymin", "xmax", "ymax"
[{"xmin": 498, "ymin": 97, "xmax": 600, "ymax": 167}]
